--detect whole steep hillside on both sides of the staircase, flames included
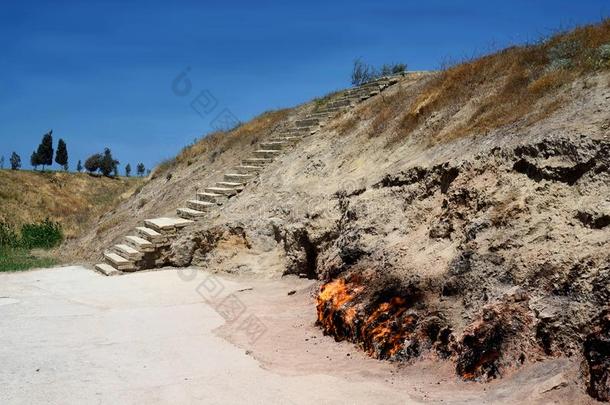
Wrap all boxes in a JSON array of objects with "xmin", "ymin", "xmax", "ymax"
[{"xmin": 65, "ymin": 20, "xmax": 610, "ymax": 402}]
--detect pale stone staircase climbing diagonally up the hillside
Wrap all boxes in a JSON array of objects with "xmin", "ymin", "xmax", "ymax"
[{"xmin": 95, "ymin": 75, "xmax": 403, "ymax": 276}]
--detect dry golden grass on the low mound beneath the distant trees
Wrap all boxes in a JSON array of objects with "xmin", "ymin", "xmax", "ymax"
[{"xmin": 0, "ymin": 170, "xmax": 143, "ymax": 238}]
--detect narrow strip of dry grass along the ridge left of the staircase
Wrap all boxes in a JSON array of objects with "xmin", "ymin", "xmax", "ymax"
[{"xmin": 154, "ymin": 109, "xmax": 290, "ymax": 177}]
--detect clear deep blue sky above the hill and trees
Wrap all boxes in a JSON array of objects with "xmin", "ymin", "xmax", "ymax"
[{"xmin": 0, "ymin": 0, "xmax": 610, "ymax": 171}]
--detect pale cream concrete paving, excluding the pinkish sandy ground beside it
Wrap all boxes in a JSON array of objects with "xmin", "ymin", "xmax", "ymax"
[{"xmin": 0, "ymin": 267, "xmax": 408, "ymax": 404}]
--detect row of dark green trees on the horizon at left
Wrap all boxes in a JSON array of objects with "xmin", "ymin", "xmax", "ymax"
[{"xmin": 0, "ymin": 130, "xmax": 150, "ymax": 177}]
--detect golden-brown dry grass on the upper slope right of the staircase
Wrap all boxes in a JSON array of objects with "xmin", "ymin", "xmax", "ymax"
[{"xmin": 346, "ymin": 19, "xmax": 610, "ymax": 145}]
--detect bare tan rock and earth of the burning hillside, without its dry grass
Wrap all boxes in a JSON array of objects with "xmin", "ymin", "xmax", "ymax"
[{"xmin": 69, "ymin": 60, "xmax": 610, "ymax": 399}]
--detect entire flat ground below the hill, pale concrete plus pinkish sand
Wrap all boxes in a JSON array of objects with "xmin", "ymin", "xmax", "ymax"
[{"xmin": 0, "ymin": 267, "xmax": 588, "ymax": 404}]
